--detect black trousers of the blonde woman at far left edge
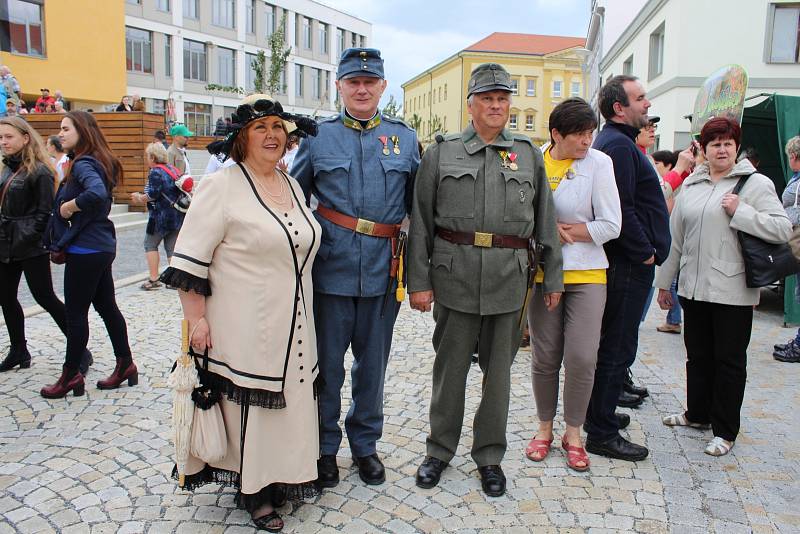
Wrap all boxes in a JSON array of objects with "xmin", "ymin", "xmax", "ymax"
[{"xmin": 0, "ymin": 254, "xmax": 67, "ymax": 350}]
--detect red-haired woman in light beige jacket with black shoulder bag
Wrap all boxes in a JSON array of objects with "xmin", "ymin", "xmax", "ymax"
[{"xmin": 655, "ymin": 118, "xmax": 792, "ymax": 456}]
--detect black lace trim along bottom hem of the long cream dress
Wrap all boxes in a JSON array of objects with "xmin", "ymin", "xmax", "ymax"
[{"xmin": 172, "ymin": 465, "xmax": 320, "ymax": 513}]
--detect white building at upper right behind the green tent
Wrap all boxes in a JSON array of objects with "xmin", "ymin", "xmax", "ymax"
[{"xmin": 587, "ymin": 0, "xmax": 800, "ymax": 150}]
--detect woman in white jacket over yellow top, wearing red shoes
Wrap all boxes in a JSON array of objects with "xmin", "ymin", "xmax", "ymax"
[{"xmin": 525, "ymin": 98, "xmax": 622, "ymax": 471}]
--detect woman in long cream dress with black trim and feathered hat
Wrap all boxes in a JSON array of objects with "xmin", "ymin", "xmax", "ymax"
[{"xmin": 161, "ymin": 95, "xmax": 320, "ymax": 532}]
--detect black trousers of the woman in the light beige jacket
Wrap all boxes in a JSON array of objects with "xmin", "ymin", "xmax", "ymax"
[{"xmin": 680, "ymin": 297, "xmax": 753, "ymax": 441}]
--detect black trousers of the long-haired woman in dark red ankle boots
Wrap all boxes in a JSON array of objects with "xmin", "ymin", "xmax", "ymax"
[{"xmin": 64, "ymin": 252, "xmax": 131, "ymax": 369}]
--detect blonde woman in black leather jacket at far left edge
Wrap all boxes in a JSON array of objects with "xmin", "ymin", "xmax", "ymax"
[{"xmin": 0, "ymin": 117, "xmax": 91, "ymax": 373}]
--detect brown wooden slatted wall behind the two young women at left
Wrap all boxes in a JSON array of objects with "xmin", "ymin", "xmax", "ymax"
[{"xmin": 21, "ymin": 111, "xmax": 214, "ymax": 211}]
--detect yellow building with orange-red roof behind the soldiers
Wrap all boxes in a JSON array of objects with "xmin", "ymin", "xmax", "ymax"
[{"xmin": 402, "ymin": 34, "xmax": 584, "ymax": 145}]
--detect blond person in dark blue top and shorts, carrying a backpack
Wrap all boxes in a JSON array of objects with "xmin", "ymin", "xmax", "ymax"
[{"xmin": 131, "ymin": 143, "xmax": 184, "ymax": 291}]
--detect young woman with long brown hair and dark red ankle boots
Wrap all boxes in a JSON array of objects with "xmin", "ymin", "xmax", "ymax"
[{"xmin": 41, "ymin": 111, "xmax": 139, "ymax": 399}]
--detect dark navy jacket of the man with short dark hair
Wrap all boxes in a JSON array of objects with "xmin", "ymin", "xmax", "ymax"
[{"xmin": 592, "ymin": 122, "xmax": 670, "ymax": 265}]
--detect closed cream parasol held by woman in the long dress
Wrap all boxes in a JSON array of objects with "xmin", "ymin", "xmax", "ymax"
[{"xmin": 167, "ymin": 320, "xmax": 200, "ymax": 488}]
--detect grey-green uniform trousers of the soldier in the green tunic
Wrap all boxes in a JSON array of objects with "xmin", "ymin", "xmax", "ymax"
[{"xmin": 427, "ymin": 304, "xmax": 522, "ymax": 467}]
